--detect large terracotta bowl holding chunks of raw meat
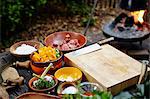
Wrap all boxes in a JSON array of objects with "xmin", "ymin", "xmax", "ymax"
[{"xmin": 44, "ymin": 31, "xmax": 87, "ymax": 52}]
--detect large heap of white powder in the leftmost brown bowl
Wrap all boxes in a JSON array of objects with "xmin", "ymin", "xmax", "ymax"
[{"xmin": 14, "ymin": 44, "xmax": 37, "ymax": 55}]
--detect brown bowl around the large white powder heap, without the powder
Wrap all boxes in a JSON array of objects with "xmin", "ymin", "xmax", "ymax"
[{"xmin": 10, "ymin": 41, "xmax": 42, "ymax": 57}]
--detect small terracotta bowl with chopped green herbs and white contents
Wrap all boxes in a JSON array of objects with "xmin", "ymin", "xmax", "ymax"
[{"xmin": 28, "ymin": 75, "xmax": 58, "ymax": 92}]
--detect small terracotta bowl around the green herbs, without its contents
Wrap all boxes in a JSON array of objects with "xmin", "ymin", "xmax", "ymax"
[{"xmin": 28, "ymin": 75, "xmax": 58, "ymax": 92}]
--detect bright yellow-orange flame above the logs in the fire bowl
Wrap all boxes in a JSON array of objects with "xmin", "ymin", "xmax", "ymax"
[{"xmin": 131, "ymin": 10, "xmax": 145, "ymax": 23}]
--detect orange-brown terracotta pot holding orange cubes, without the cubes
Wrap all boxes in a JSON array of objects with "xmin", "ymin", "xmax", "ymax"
[{"xmin": 30, "ymin": 52, "xmax": 63, "ymax": 74}]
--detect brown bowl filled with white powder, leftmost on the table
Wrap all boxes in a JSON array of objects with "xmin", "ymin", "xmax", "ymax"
[{"xmin": 10, "ymin": 40, "xmax": 42, "ymax": 57}]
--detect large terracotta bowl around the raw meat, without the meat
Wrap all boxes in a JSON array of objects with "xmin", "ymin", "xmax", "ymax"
[{"xmin": 44, "ymin": 31, "xmax": 87, "ymax": 52}]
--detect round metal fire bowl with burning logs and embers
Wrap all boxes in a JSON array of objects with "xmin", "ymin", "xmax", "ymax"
[{"xmin": 103, "ymin": 10, "xmax": 150, "ymax": 42}]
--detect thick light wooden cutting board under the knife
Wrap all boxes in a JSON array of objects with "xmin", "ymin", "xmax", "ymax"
[{"xmin": 65, "ymin": 44, "xmax": 146, "ymax": 95}]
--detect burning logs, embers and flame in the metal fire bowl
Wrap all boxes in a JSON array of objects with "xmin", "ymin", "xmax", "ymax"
[{"xmin": 110, "ymin": 10, "xmax": 149, "ymax": 32}]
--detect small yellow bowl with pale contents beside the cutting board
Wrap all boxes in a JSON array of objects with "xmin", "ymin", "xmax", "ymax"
[{"xmin": 54, "ymin": 67, "xmax": 82, "ymax": 83}]
